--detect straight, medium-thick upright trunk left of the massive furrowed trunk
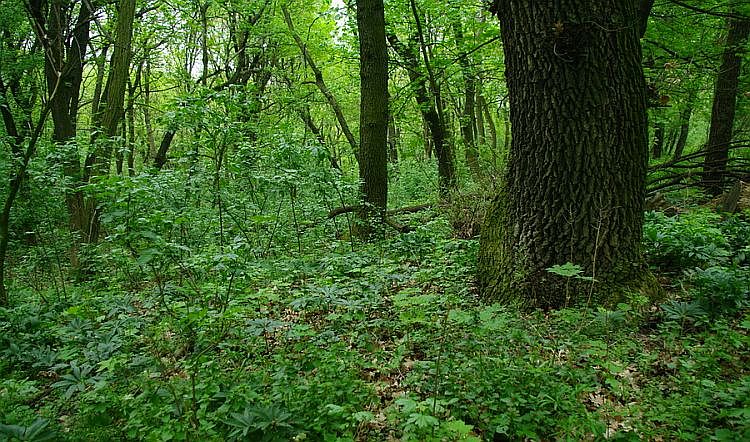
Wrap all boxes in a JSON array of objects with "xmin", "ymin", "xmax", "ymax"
[{"xmin": 356, "ymin": 0, "xmax": 388, "ymax": 238}]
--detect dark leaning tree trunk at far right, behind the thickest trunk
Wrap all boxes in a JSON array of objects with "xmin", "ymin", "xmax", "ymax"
[{"xmin": 702, "ymin": 19, "xmax": 750, "ymax": 195}]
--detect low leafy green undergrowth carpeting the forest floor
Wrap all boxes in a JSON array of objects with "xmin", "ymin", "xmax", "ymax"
[{"xmin": 0, "ymin": 211, "xmax": 750, "ymax": 441}]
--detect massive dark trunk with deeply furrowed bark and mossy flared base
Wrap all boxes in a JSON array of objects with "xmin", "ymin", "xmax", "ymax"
[{"xmin": 478, "ymin": 0, "xmax": 659, "ymax": 308}]
